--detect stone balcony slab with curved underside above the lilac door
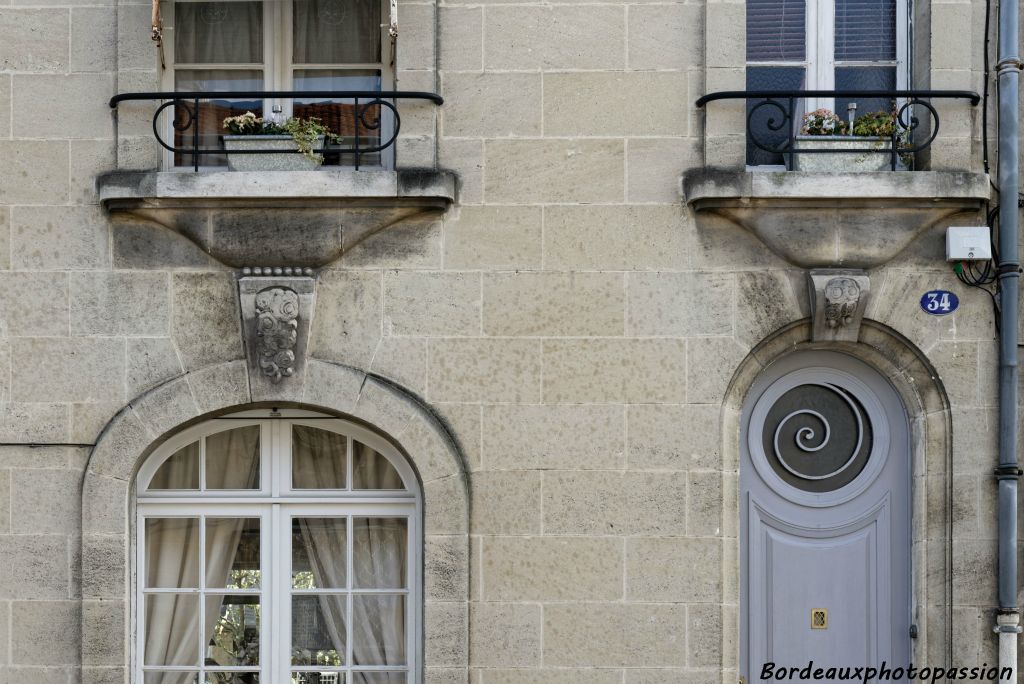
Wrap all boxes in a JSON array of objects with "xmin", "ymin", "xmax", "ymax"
[{"xmin": 682, "ymin": 169, "xmax": 990, "ymax": 268}]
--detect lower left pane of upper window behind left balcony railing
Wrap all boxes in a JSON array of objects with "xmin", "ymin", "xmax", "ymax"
[{"xmin": 170, "ymin": 69, "xmax": 263, "ymax": 166}]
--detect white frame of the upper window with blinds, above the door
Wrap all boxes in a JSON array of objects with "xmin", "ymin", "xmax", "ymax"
[{"xmin": 746, "ymin": 0, "xmax": 910, "ymax": 120}]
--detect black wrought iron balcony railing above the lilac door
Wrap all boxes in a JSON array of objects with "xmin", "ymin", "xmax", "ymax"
[{"xmin": 696, "ymin": 90, "xmax": 981, "ymax": 170}]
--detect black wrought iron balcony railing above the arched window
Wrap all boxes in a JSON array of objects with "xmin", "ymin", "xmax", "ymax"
[{"xmin": 110, "ymin": 90, "xmax": 444, "ymax": 171}]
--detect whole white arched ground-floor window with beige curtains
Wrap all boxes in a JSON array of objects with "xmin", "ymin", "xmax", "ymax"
[{"xmin": 135, "ymin": 410, "xmax": 422, "ymax": 684}]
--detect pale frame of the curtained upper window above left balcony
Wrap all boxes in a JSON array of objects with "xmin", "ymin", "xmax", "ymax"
[{"xmin": 161, "ymin": 0, "xmax": 395, "ymax": 171}]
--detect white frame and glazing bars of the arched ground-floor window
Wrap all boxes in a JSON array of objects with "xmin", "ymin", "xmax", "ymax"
[{"xmin": 132, "ymin": 409, "xmax": 423, "ymax": 684}]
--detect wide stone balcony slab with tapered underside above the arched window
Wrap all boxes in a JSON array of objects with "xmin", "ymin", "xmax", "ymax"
[{"xmin": 96, "ymin": 168, "xmax": 456, "ymax": 268}]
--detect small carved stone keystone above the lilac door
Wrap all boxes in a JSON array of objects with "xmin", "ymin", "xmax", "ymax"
[{"xmin": 807, "ymin": 268, "xmax": 871, "ymax": 342}]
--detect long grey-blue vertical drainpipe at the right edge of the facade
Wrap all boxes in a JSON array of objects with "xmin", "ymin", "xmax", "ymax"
[{"xmin": 993, "ymin": 0, "xmax": 1021, "ymax": 667}]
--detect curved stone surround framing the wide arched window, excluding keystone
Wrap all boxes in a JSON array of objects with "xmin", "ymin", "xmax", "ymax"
[{"xmin": 81, "ymin": 358, "xmax": 469, "ymax": 684}]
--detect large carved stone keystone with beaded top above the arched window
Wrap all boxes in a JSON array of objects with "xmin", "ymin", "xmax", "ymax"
[{"xmin": 239, "ymin": 268, "xmax": 316, "ymax": 400}]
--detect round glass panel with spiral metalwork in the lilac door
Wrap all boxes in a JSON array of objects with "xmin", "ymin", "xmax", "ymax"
[{"xmin": 761, "ymin": 383, "xmax": 872, "ymax": 493}]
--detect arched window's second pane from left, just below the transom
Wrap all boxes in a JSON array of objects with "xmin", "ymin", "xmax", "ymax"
[{"xmin": 206, "ymin": 518, "xmax": 260, "ymax": 589}]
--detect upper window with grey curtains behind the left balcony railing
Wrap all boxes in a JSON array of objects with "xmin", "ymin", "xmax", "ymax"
[{"xmin": 165, "ymin": 0, "xmax": 393, "ymax": 166}]
